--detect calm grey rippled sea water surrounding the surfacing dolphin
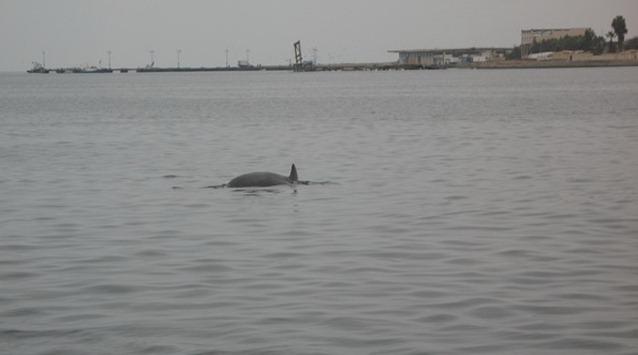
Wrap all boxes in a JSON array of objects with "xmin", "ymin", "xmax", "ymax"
[{"xmin": 0, "ymin": 68, "xmax": 638, "ymax": 355}]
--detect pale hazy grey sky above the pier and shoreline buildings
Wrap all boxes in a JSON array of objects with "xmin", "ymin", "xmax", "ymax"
[{"xmin": 0, "ymin": 0, "xmax": 638, "ymax": 71}]
